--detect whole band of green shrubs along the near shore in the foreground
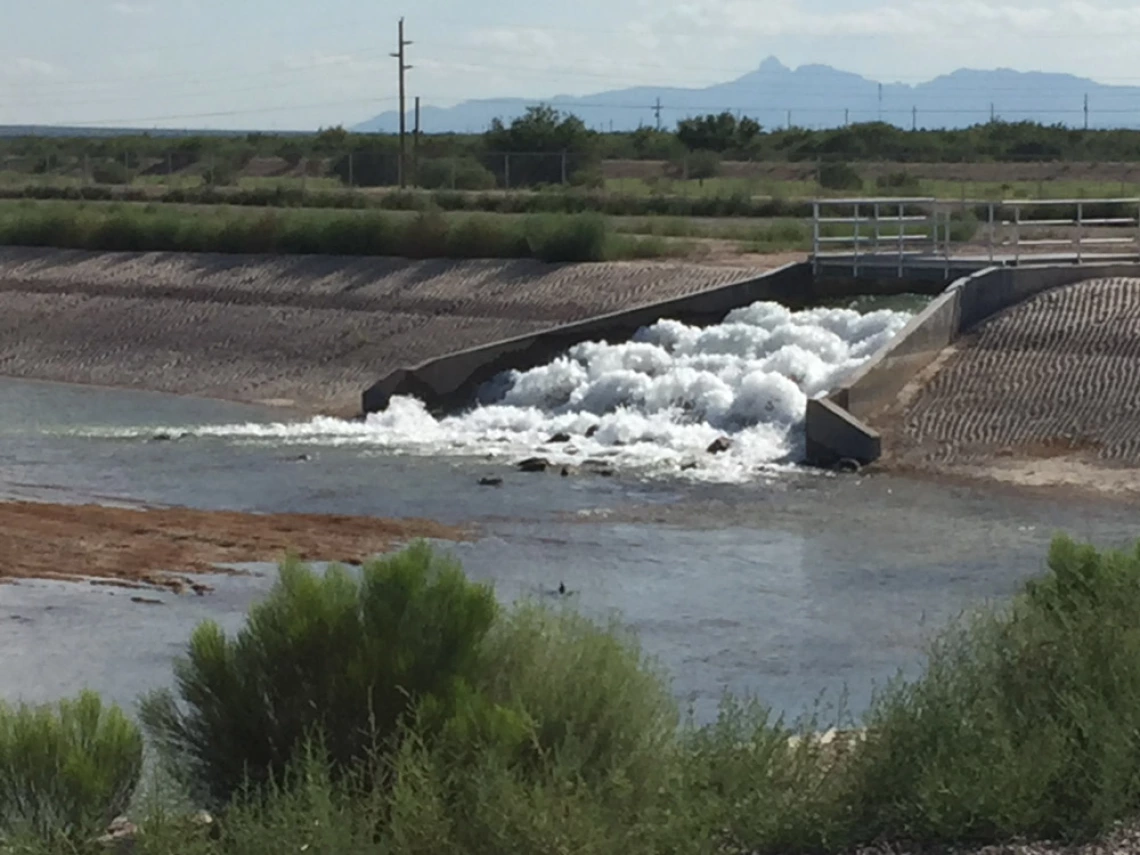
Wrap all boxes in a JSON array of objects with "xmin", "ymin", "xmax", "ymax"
[{"xmin": 11, "ymin": 537, "xmax": 1140, "ymax": 855}]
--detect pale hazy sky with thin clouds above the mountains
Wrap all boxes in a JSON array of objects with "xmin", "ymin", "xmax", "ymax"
[{"xmin": 0, "ymin": 0, "xmax": 1140, "ymax": 129}]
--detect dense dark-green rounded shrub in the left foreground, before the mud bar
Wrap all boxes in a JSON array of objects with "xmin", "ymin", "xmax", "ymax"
[{"xmin": 141, "ymin": 544, "xmax": 496, "ymax": 805}]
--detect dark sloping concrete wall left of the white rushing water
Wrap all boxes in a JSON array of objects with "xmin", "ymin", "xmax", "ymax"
[{"xmin": 363, "ymin": 262, "xmax": 815, "ymax": 413}]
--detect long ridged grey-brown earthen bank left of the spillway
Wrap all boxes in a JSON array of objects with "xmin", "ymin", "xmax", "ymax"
[{"xmin": 0, "ymin": 247, "xmax": 783, "ymax": 415}]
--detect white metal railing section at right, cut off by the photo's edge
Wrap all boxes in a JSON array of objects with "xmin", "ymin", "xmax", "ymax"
[{"xmin": 986, "ymin": 198, "xmax": 1140, "ymax": 264}]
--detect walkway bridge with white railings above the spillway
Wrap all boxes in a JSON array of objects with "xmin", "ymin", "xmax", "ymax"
[{"xmin": 811, "ymin": 197, "xmax": 1140, "ymax": 282}]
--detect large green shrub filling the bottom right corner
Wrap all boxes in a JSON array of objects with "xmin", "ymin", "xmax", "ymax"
[{"xmin": 848, "ymin": 538, "xmax": 1140, "ymax": 841}]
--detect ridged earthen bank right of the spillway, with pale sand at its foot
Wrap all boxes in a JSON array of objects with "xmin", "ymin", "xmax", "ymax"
[{"xmin": 872, "ymin": 278, "xmax": 1140, "ymax": 496}]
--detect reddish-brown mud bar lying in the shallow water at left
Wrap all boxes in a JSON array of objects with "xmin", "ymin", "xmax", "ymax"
[{"xmin": 0, "ymin": 502, "xmax": 470, "ymax": 589}]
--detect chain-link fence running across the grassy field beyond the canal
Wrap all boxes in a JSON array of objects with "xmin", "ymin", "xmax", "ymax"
[{"xmin": 0, "ymin": 149, "xmax": 1140, "ymax": 202}]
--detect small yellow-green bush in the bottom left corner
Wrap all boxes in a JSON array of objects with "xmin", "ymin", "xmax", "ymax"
[{"xmin": 0, "ymin": 692, "xmax": 143, "ymax": 842}]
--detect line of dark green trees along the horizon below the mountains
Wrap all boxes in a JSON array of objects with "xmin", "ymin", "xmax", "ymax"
[{"xmin": 0, "ymin": 105, "xmax": 1140, "ymax": 189}]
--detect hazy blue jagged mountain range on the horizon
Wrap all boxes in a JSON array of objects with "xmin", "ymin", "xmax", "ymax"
[{"xmin": 352, "ymin": 57, "xmax": 1140, "ymax": 133}]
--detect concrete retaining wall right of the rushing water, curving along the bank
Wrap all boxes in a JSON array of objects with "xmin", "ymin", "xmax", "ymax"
[{"xmin": 805, "ymin": 263, "xmax": 1140, "ymax": 466}]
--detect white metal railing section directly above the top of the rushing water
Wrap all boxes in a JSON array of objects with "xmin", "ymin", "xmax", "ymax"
[{"xmin": 812, "ymin": 197, "xmax": 951, "ymax": 277}]
